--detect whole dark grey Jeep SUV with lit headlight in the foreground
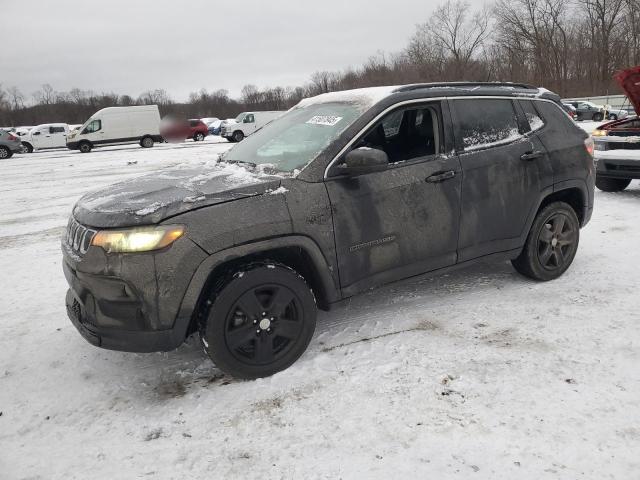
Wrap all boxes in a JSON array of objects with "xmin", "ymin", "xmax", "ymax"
[{"xmin": 62, "ymin": 83, "xmax": 595, "ymax": 378}]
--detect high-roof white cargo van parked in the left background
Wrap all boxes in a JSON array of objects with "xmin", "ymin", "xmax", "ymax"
[{"xmin": 67, "ymin": 105, "xmax": 162, "ymax": 153}]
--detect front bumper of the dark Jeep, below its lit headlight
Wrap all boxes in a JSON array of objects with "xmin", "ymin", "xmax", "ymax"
[{"xmin": 62, "ymin": 229, "xmax": 206, "ymax": 352}]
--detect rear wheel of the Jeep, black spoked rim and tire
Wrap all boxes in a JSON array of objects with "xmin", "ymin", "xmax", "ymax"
[{"xmin": 511, "ymin": 202, "xmax": 580, "ymax": 282}]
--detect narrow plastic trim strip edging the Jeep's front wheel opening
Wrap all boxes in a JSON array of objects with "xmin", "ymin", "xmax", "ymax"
[{"xmin": 173, "ymin": 235, "xmax": 341, "ymax": 340}]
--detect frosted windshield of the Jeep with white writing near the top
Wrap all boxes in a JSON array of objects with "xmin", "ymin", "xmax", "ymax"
[{"xmin": 223, "ymin": 102, "xmax": 361, "ymax": 172}]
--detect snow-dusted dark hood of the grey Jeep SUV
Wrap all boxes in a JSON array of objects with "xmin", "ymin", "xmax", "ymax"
[{"xmin": 73, "ymin": 163, "xmax": 282, "ymax": 228}]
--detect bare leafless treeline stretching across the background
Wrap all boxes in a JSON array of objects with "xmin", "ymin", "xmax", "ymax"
[{"xmin": 0, "ymin": 0, "xmax": 640, "ymax": 126}]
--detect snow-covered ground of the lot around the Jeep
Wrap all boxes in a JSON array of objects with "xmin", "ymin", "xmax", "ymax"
[{"xmin": 0, "ymin": 136, "xmax": 640, "ymax": 480}]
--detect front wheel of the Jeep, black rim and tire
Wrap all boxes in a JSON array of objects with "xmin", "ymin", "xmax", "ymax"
[{"xmin": 200, "ymin": 263, "xmax": 317, "ymax": 379}]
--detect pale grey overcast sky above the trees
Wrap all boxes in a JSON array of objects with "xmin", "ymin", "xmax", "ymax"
[{"xmin": 0, "ymin": 0, "xmax": 478, "ymax": 100}]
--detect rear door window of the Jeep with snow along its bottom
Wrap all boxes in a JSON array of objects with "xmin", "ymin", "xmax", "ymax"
[{"xmin": 453, "ymin": 98, "xmax": 521, "ymax": 151}]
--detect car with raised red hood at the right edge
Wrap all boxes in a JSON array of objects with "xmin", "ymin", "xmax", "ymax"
[{"xmin": 592, "ymin": 66, "xmax": 640, "ymax": 192}]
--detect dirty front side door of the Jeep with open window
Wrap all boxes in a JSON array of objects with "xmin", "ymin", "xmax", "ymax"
[{"xmin": 326, "ymin": 102, "xmax": 461, "ymax": 295}]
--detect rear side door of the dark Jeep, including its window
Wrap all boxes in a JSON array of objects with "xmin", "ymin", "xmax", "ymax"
[{"xmin": 450, "ymin": 98, "xmax": 547, "ymax": 261}]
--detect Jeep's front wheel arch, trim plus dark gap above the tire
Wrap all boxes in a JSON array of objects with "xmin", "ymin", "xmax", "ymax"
[{"xmin": 174, "ymin": 235, "xmax": 340, "ymax": 338}]
